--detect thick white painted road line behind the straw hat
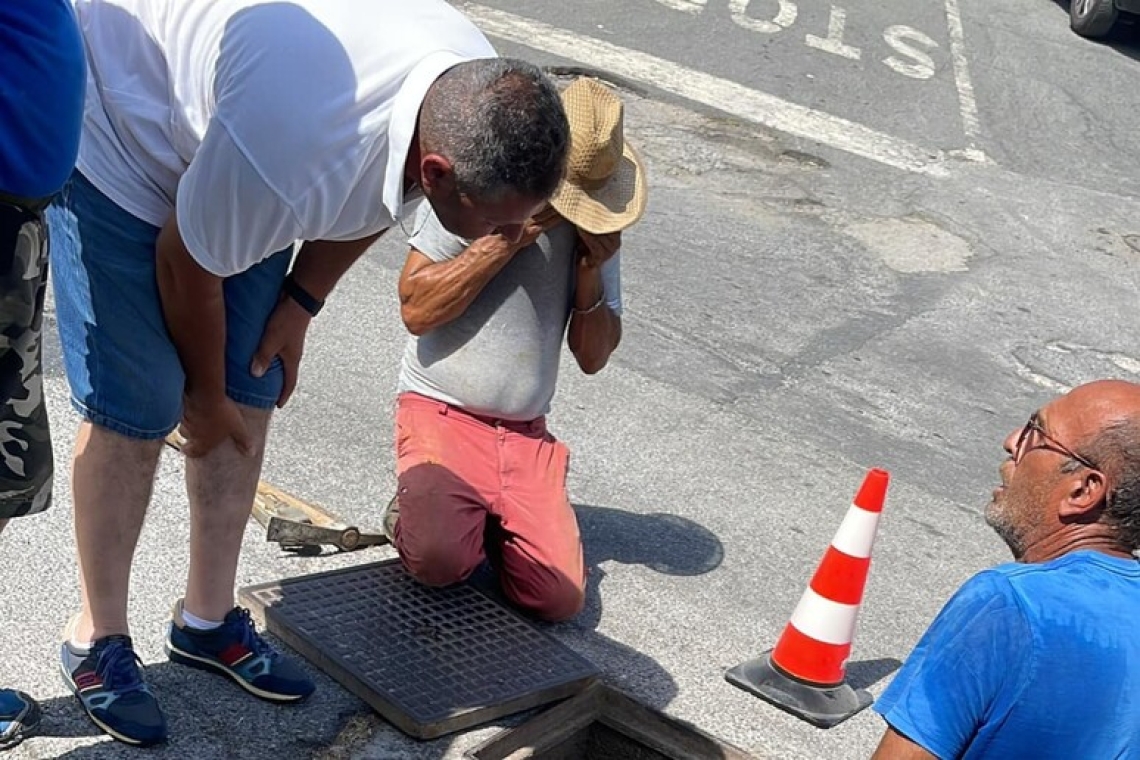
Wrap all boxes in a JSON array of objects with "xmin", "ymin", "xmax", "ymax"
[{"xmin": 463, "ymin": 3, "xmax": 950, "ymax": 177}]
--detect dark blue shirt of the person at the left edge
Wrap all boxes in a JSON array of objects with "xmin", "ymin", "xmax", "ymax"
[{"xmin": 0, "ymin": 0, "xmax": 87, "ymax": 198}]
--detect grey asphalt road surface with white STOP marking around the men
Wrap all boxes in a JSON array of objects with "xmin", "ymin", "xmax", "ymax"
[{"xmin": 0, "ymin": 0, "xmax": 1140, "ymax": 760}]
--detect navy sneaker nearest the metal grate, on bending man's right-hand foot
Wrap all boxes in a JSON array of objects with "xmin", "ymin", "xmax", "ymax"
[{"xmin": 166, "ymin": 599, "xmax": 317, "ymax": 702}]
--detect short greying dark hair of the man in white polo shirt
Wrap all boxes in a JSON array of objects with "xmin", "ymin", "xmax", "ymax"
[{"xmin": 420, "ymin": 58, "xmax": 570, "ymax": 201}]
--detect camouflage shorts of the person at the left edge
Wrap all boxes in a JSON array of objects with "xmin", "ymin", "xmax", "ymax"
[{"xmin": 0, "ymin": 198, "xmax": 52, "ymax": 520}]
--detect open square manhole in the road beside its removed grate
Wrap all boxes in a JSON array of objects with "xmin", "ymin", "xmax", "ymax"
[{"xmin": 466, "ymin": 683, "xmax": 755, "ymax": 760}]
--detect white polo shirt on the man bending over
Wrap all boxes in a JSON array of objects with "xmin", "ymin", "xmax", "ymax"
[{"xmin": 75, "ymin": 0, "xmax": 496, "ymax": 276}]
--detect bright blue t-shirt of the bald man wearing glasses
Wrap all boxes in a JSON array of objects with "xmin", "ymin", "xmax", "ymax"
[{"xmin": 876, "ymin": 550, "xmax": 1140, "ymax": 760}]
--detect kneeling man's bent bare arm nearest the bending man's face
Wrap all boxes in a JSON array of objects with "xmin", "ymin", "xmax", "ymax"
[{"xmin": 399, "ymin": 223, "xmax": 543, "ymax": 335}]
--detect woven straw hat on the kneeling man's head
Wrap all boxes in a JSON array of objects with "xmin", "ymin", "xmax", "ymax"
[{"xmin": 551, "ymin": 77, "xmax": 649, "ymax": 235}]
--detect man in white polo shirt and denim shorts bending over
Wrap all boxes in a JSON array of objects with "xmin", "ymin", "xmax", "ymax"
[{"xmin": 48, "ymin": 0, "xmax": 568, "ymax": 744}]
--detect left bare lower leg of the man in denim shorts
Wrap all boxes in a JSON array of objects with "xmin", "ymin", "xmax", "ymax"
[{"xmin": 71, "ymin": 422, "xmax": 162, "ymax": 641}]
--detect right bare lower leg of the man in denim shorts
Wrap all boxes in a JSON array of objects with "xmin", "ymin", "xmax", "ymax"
[{"xmin": 184, "ymin": 407, "xmax": 271, "ymax": 621}]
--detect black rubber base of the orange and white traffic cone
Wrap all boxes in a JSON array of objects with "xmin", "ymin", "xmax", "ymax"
[{"xmin": 724, "ymin": 649, "xmax": 873, "ymax": 728}]
